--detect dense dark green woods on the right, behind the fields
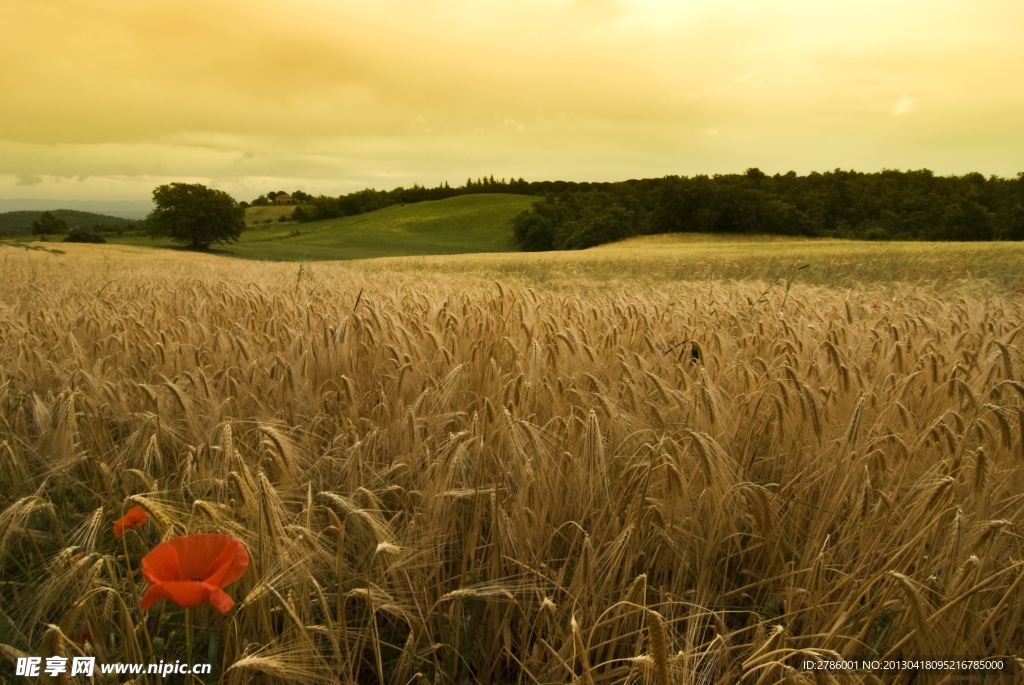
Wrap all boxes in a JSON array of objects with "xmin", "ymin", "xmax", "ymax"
[{"xmin": 513, "ymin": 168, "xmax": 1024, "ymax": 251}]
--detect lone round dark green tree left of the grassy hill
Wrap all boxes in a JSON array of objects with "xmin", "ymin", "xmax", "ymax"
[{"xmin": 146, "ymin": 183, "xmax": 246, "ymax": 250}]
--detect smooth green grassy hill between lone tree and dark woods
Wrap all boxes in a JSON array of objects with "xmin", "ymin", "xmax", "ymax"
[{"xmin": 109, "ymin": 195, "xmax": 539, "ymax": 261}]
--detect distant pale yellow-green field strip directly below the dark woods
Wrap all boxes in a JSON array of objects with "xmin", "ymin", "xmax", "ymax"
[{"xmin": 362, "ymin": 233, "xmax": 1024, "ymax": 290}]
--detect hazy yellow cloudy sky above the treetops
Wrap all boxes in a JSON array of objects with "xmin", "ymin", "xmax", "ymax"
[{"xmin": 0, "ymin": 0, "xmax": 1024, "ymax": 200}]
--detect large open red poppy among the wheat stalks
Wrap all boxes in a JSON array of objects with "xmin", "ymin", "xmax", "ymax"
[{"xmin": 142, "ymin": 532, "xmax": 249, "ymax": 613}]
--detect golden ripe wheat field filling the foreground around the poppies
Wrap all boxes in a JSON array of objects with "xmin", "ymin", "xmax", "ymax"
[{"xmin": 0, "ymin": 246, "xmax": 1024, "ymax": 685}]
